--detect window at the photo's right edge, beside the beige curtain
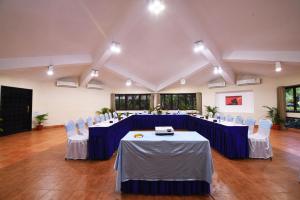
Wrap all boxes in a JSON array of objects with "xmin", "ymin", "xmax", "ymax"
[{"xmin": 285, "ymin": 86, "xmax": 300, "ymax": 112}]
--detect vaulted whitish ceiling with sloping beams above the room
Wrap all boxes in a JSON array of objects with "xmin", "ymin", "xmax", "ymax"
[{"xmin": 0, "ymin": 0, "xmax": 300, "ymax": 91}]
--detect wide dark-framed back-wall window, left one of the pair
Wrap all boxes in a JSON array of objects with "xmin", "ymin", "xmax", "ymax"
[{"xmin": 115, "ymin": 94, "xmax": 150, "ymax": 110}]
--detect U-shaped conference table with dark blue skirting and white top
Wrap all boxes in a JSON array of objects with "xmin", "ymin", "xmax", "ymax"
[{"xmin": 88, "ymin": 114, "xmax": 249, "ymax": 160}]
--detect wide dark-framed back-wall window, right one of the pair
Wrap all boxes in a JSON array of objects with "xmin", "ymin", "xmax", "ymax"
[{"xmin": 160, "ymin": 93, "xmax": 196, "ymax": 110}]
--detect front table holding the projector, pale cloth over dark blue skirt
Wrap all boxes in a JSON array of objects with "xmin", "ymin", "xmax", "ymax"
[{"xmin": 115, "ymin": 131, "xmax": 213, "ymax": 195}]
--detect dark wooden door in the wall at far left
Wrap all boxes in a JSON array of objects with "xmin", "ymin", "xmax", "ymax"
[{"xmin": 1, "ymin": 86, "xmax": 32, "ymax": 135}]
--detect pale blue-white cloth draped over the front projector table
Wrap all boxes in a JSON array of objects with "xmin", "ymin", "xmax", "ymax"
[{"xmin": 115, "ymin": 131, "xmax": 213, "ymax": 191}]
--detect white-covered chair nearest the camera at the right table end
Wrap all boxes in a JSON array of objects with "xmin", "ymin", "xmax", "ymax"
[{"xmin": 248, "ymin": 119, "xmax": 273, "ymax": 159}]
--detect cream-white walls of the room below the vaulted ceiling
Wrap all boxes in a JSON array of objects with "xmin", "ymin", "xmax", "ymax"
[{"xmin": 0, "ymin": 74, "xmax": 300, "ymax": 125}]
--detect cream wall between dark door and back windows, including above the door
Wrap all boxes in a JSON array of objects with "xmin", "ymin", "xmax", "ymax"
[{"xmin": 0, "ymin": 76, "xmax": 111, "ymax": 126}]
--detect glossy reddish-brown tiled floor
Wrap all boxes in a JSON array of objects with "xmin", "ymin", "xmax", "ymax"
[{"xmin": 0, "ymin": 128, "xmax": 300, "ymax": 200}]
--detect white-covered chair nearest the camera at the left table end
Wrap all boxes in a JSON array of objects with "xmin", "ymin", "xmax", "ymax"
[{"xmin": 65, "ymin": 121, "xmax": 88, "ymax": 159}]
